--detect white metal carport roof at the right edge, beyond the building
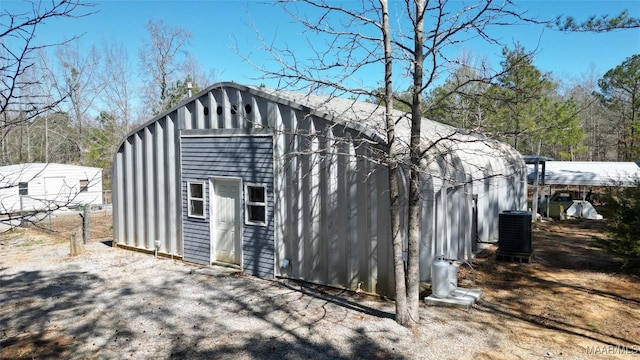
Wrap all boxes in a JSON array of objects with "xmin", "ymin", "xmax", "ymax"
[{"xmin": 527, "ymin": 161, "xmax": 640, "ymax": 186}]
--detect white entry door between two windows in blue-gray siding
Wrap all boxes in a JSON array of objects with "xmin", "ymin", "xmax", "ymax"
[{"xmin": 211, "ymin": 179, "xmax": 241, "ymax": 265}]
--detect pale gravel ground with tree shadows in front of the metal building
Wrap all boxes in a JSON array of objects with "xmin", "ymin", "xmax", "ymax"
[{"xmin": 0, "ymin": 222, "xmax": 640, "ymax": 359}]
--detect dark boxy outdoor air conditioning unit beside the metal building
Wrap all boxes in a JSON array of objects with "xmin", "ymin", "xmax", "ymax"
[{"xmin": 498, "ymin": 210, "xmax": 533, "ymax": 255}]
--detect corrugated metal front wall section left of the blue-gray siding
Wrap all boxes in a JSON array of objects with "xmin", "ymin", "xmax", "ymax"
[{"xmin": 113, "ymin": 110, "xmax": 182, "ymax": 255}]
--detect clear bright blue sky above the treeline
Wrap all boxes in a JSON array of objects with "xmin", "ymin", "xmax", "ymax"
[{"xmin": 0, "ymin": 0, "xmax": 640, "ymax": 92}]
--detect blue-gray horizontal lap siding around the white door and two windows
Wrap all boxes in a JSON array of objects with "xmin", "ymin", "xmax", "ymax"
[{"xmin": 181, "ymin": 132, "xmax": 274, "ymax": 277}]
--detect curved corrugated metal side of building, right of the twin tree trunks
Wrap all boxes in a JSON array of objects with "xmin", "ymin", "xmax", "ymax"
[{"xmin": 420, "ymin": 133, "xmax": 526, "ymax": 281}]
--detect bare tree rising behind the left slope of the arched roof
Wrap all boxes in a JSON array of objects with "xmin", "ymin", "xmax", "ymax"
[{"xmin": 139, "ymin": 20, "xmax": 193, "ymax": 114}]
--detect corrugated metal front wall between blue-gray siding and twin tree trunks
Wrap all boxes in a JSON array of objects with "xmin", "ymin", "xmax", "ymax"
[{"xmin": 270, "ymin": 104, "xmax": 393, "ymax": 294}]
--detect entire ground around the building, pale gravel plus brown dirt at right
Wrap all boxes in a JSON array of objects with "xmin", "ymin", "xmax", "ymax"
[{"xmin": 0, "ymin": 213, "xmax": 640, "ymax": 359}]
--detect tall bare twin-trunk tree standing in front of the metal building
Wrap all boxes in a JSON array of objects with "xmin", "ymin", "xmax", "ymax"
[{"xmin": 246, "ymin": 0, "xmax": 534, "ymax": 326}]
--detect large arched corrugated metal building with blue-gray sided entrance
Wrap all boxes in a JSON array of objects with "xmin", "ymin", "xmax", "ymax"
[{"xmin": 113, "ymin": 83, "xmax": 526, "ymax": 294}]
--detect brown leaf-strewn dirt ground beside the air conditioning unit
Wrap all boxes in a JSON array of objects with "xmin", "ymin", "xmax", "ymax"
[{"xmin": 466, "ymin": 219, "xmax": 640, "ymax": 357}]
